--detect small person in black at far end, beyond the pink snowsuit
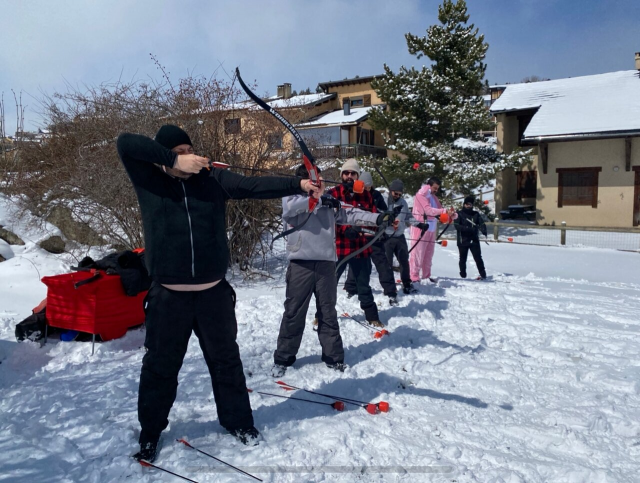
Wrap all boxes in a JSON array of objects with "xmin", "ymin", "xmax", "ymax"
[{"xmin": 454, "ymin": 196, "xmax": 487, "ymax": 280}]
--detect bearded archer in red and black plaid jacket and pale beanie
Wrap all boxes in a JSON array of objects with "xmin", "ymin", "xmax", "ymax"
[{"xmin": 327, "ymin": 159, "xmax": 383, "ymax": 327}]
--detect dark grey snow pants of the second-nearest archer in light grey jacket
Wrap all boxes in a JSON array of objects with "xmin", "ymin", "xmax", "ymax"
[{"xmin": 273, "ymin": 260, "xmax": 344, "ymax": 366}]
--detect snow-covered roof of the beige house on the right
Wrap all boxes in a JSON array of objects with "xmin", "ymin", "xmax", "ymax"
[{"xmin": 491, "ymin": 70, "xmax": 640, "ymax": 139}]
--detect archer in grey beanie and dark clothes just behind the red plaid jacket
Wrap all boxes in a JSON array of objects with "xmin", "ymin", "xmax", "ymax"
[{"xmin": 344, "ymin": 171, "xmax": 398, "ymax": 305}]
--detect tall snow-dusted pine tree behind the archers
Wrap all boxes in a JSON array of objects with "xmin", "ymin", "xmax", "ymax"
[{"xmin": 369, "ymin": 0, "xmax": 527, "ymax": 197}]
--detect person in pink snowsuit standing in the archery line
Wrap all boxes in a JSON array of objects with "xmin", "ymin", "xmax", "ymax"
[{"xmin": 409, "ymin": 177, "xmax": 458, "ymax": 282}]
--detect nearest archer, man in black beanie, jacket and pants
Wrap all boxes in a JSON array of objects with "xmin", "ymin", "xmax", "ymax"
[{"xmin": 117, "ymin": 125, "xmax": 319, "ymax": 461}]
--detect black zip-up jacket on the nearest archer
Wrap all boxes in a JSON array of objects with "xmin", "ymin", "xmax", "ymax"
[{"xmin": 117, "ymin": 133, "xmax": 303, "ymax": 285}]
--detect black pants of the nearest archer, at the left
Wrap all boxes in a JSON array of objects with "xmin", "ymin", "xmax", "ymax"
[{"xmin": 138, "ymin": 280, "xmax": 253, "ymax": 443}]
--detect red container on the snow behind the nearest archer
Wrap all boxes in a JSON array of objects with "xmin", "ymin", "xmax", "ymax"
[{"xmin": 42, "ymin": 271, "xmax": 147, "ymax": 340}]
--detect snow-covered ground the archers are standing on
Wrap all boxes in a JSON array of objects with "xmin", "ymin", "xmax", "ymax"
[{"xmin": 0, "ymin": 198, "xmax": 640, "ymax": 483}]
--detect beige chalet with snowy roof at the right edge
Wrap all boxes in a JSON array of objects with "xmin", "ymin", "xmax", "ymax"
[{"xmin": 490, "ymin": 53, "xmax": 640, "ymax": 227}]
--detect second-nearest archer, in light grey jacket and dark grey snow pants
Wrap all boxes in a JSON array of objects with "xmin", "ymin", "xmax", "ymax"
[{"xmin": 272, "ymin": 165, "xmax": 389, "ymax": 377}]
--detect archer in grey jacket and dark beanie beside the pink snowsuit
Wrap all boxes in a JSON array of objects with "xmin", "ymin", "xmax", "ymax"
[{"xmin": 385, "ymin": 179, "xmax": 427, "ymax": 294}]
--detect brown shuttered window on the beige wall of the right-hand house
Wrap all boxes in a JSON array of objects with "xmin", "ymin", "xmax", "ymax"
[{"xmin": 556, "ymin": 168, "xmax": 602, "ymax": 208}]
